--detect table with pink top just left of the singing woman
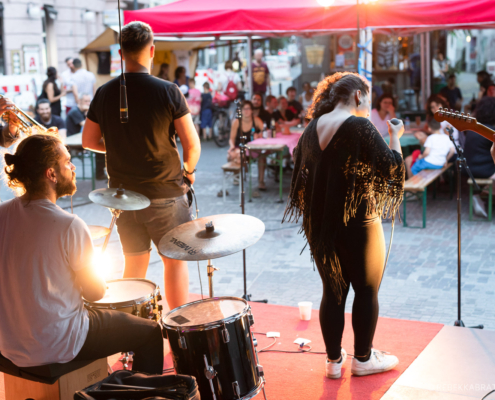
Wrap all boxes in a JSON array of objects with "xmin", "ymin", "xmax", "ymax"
[{"xmin": 247, "ymin": 133, "xmax": 301, "ymax": 203}]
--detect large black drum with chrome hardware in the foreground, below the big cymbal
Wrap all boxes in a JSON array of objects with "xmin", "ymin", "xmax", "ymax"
[{"xmin": 162, "ymin": 297, "xmax": 265, "ymax": 400}]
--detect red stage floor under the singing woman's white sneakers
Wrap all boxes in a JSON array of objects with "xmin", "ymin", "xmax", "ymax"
[{"xmin": 0, "ymin": 295, "xmax": 443, "ymax": 400}]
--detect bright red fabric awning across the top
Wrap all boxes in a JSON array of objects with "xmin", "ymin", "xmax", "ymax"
[{"xmin": 124, "ymin": 0, "xmax": 495, "ymax": 37}]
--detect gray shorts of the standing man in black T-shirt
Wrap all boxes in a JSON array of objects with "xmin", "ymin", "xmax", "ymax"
[{"xmin": 117, "ymin": 195, "xmax": 192, "ymax": 256}]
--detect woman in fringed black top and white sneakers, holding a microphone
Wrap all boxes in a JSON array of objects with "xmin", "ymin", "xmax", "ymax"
[{"xmin": 284, "ymin": 72, "xmax": 405, "ymax": 378}]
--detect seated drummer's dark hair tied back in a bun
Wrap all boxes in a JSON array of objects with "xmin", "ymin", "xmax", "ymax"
[{"xmin": 5, "ymin": 133, "xmax": 62, "ymax": 195}]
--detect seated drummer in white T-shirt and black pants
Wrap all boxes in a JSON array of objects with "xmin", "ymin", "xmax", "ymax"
[{"xmin": 0, "ymin": 134, "xmax": 163, "ymax": 374}]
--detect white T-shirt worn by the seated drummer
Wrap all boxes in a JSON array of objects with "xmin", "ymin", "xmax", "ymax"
[{"xmin": 0, "ymin": 198, "xmax": 93, "ymax": 367}]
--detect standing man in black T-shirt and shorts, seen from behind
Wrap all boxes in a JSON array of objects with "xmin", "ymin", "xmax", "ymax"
[{"xmin": 82, "ymin": 21, "xmax": 201, "ymax": 309}]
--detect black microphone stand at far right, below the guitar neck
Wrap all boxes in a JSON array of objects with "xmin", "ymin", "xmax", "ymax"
[{"xmin": 446, "ymin": 127, "xmax": 483, "ymax": 329}]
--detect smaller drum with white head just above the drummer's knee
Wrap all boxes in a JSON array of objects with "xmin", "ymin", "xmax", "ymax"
[{"xmin": 84, "ymin": 278, "xmax": 162, "ymax": 321}]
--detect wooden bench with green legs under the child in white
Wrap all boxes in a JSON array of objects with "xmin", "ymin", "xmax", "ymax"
[{"xmin": 403, "ymin": 163, "xmax": 453, "ymax": 228}]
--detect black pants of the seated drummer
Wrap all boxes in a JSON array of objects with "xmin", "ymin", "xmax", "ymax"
[{"xmin": 74, "ymin": 309, "xmax": 163, "ymax": 375}]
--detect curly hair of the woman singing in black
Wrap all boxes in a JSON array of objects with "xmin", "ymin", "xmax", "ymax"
[{"xmin": 307, "ymin": 72, "xmax": 370, "ymax": 119}]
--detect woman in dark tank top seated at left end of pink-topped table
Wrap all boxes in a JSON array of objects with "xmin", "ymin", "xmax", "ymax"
[{"xmin": 227, "ymin": 100, "xmax": 266, "ymax": 190}]
